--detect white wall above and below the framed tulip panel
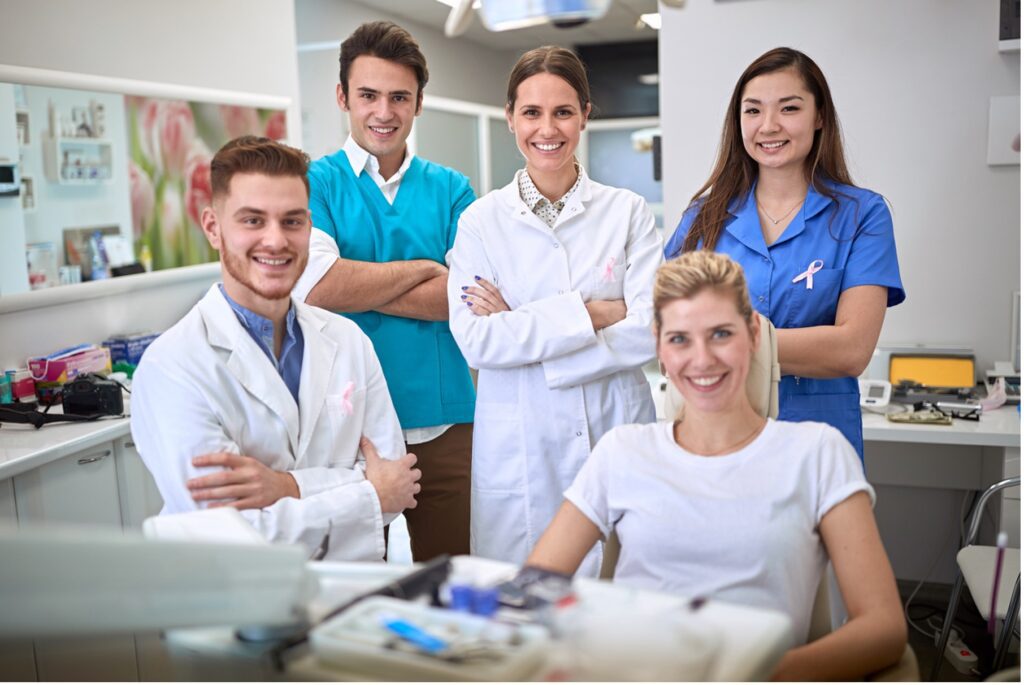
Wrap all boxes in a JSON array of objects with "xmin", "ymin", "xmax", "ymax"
[{"xmin": 0, "ymin": 0, "xmax": 301, "ymax": 368}]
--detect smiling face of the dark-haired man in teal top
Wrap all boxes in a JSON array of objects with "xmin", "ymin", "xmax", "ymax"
[{"xmin": 337, "ymin": 55, "xmax": 422, "ymax": 178}]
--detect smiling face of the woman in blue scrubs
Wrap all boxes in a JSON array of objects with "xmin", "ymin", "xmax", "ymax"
[{"xmin": 739, "ymin": 69, "xmax": 821, "ymax": 173}]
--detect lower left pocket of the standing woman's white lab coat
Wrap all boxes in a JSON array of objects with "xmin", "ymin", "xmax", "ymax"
[{"xmin": 472, "ymin": 401, "xmax": 526, "ymax": 493}]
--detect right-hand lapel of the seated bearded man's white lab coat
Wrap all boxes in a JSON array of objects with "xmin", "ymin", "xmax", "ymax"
[{"xmin": 293, "ymin": 302, "xmax": 338, "ymax": 461}]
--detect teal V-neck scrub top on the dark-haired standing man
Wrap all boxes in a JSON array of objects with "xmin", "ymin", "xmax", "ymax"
[{"xmin": 309, "ymin": 151, "xmax": 476, "ymax": 429}]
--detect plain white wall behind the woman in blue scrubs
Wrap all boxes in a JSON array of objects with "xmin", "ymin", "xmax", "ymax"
[{"xmin": 660, "ymin": 0, "xmax": 1021, "ymax": 372}]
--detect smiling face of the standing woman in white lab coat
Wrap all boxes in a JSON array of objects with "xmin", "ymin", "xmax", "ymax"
[{"xmin": 505, "ymin": 72, "xmax": 590, "ymax": 187}]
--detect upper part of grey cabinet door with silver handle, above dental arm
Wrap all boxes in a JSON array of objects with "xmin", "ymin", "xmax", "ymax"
[{"xmin": 14, "ymin": 442, "xmax": 121, "ymax": 528}]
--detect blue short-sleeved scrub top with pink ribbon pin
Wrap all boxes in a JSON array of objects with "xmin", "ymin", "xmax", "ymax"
[{"xmin": 665, "ymin": 182, "xmax": 906, "ymax": 461}]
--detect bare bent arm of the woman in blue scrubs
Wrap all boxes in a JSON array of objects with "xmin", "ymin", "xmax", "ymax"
[{"xmin": 775, "ymin": 286, "xmax": 888, "ymax": 378}]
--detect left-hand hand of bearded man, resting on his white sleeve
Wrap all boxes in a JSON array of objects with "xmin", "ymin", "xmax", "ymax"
[{"xmin": 185, "ymin": 452, "xmax": 299, "ymax": 509}]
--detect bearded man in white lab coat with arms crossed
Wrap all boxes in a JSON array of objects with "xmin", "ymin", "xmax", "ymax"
[{"xmin": 131, "ymin": 136, "xmax": 420, "ymax": 560}]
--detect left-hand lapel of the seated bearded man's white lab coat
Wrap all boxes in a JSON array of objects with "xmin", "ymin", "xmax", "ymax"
[{"xmin": 199, "ymin": 285, "xmax": 306, "ymax": 458}]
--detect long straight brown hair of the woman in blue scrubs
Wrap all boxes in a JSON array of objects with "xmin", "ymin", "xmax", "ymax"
[{"xmin": 682, "ymin": 47, "xmax": 853, "ymax": 252}]
